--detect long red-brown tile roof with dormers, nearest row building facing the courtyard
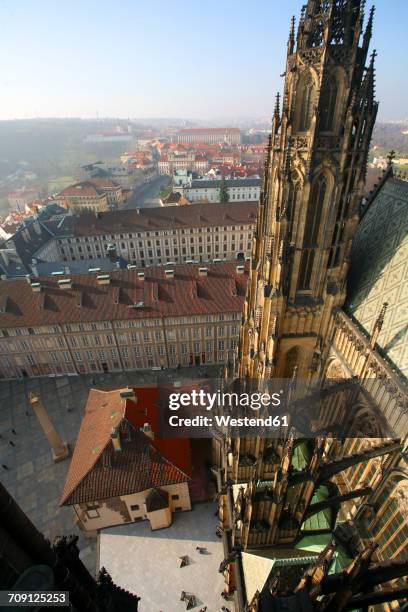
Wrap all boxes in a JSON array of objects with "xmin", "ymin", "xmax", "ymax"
[{"xmin": 0, "ymin": 262, "xmax": 248, "ymax": 329}]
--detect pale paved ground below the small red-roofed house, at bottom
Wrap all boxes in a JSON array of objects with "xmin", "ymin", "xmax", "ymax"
[{"xmin": 99, "ymin": 503, "xmax": 228, "ymax": 612}]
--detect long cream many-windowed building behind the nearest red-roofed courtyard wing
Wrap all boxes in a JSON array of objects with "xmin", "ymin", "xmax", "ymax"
[{"xmin": 40, "ymin": 202, "xmax": 257, "ymax": 267}]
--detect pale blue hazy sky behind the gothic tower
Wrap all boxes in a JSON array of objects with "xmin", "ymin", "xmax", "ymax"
[{"xmin": 0, "ymin": 0, "xmax": 408, "ymax": 120}]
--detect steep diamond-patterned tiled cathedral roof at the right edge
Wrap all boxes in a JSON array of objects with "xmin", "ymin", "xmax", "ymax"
[{"xmin": 346, "ymin": 175, "xmax": 408, "ymax": 375}]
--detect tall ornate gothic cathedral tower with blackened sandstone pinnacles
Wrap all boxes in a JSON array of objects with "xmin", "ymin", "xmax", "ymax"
[{"xmin": 235, "ymin": 0, "xmax": 377, "ymax": 380}]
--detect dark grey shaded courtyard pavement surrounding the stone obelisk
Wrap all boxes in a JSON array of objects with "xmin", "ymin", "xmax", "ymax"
[{"xmin": 0, "ymin": 367, "xmax": 218, "ymax": 573}]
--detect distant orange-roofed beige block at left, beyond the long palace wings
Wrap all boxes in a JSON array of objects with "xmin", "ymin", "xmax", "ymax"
[{"xmin": 54, "ymin": 177, "xmax": 123, "ymax": 211}]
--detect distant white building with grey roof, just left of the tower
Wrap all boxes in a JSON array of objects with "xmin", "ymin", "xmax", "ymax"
[{"xmin": 178, "ymin": 178, "xmax": 261, "ymax": 202}]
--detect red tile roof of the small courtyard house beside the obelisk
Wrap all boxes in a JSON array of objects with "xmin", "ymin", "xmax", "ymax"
[{"xmin": 61, "ymin": 386, "xmax": 192, "ymax": 505}]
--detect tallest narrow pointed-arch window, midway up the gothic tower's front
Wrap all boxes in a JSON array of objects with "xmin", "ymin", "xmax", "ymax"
[{"xmin": 298, "ymin": 175, "xmax": 327, "ymax": 291}]
